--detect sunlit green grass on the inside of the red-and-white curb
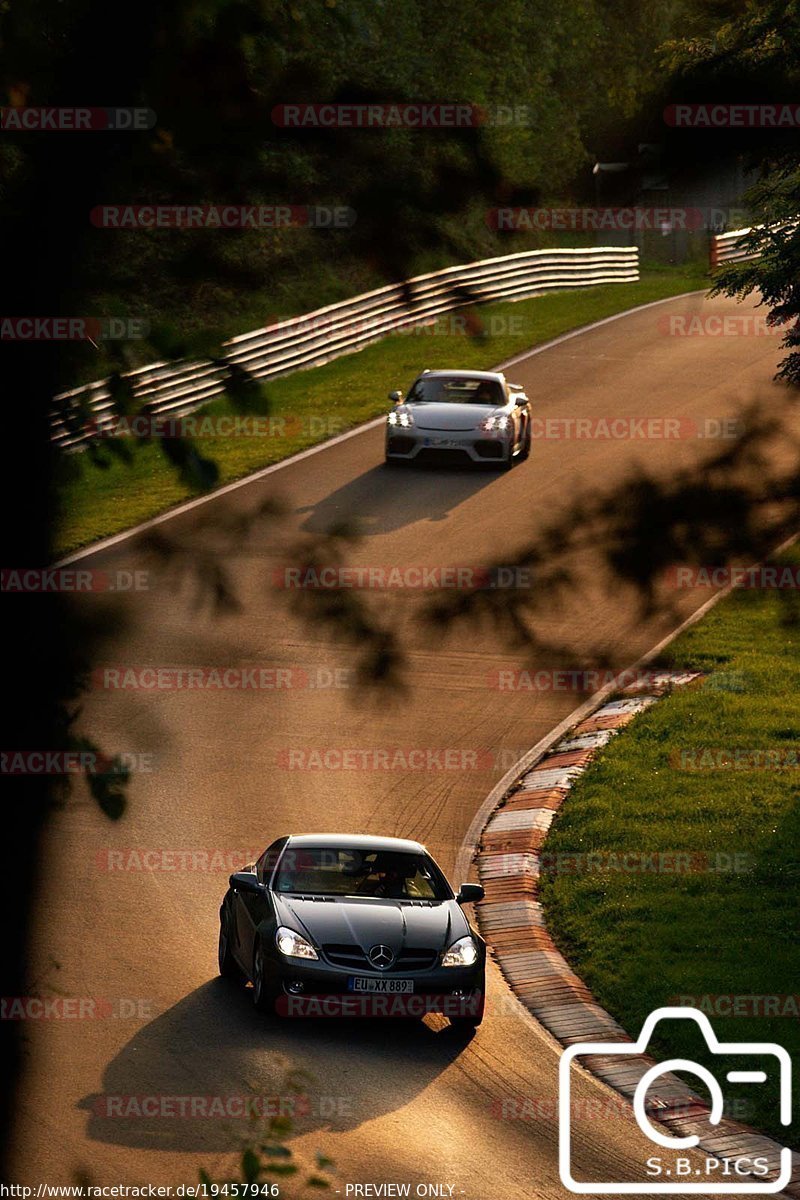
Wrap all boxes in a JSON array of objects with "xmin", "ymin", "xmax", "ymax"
[{"xmin": 542, "ymin": 551, "xmax": 800, "ymax": 1145}]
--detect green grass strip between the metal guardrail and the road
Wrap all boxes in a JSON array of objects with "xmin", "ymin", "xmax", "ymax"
[{"xmin": 55, "ymin": 270, "xmax": 705, "ymax": 554}]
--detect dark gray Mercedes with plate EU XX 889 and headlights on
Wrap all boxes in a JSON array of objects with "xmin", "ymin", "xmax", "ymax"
[{"xmin": 219, "ymin": 834, "xmax": 486, "ymax": 1027}]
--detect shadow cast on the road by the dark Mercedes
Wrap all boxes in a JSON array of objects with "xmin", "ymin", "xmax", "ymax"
[{"xmin": 79, "ymin": 979, "xmax": 469, "ymax": 1152}]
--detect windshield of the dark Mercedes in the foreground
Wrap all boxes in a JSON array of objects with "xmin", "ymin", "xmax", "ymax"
[{"xmin": 275, "ymin": 846, "xmax": 452, "ymax": 900}]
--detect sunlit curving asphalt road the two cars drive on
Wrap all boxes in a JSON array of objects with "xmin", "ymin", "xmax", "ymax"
[{"xmin": 9, "ymin": 298, "xmax": 786, "ymax": 1200}]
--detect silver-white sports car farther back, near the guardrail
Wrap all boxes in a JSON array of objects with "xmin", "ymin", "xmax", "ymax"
[{"xmin": 386, "ymin": 371, "xmax": 531, "ymax": 470}]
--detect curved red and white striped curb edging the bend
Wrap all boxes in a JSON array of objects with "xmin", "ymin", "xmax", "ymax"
[{"xmin": 477, "ymin": 672, "xmax": 800, "ymax": 1198}]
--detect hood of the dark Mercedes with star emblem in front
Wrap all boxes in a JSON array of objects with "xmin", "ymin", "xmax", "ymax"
[{"xmin": 275, "ymin": 895, "xmax": 469, "ymax": 954}]
